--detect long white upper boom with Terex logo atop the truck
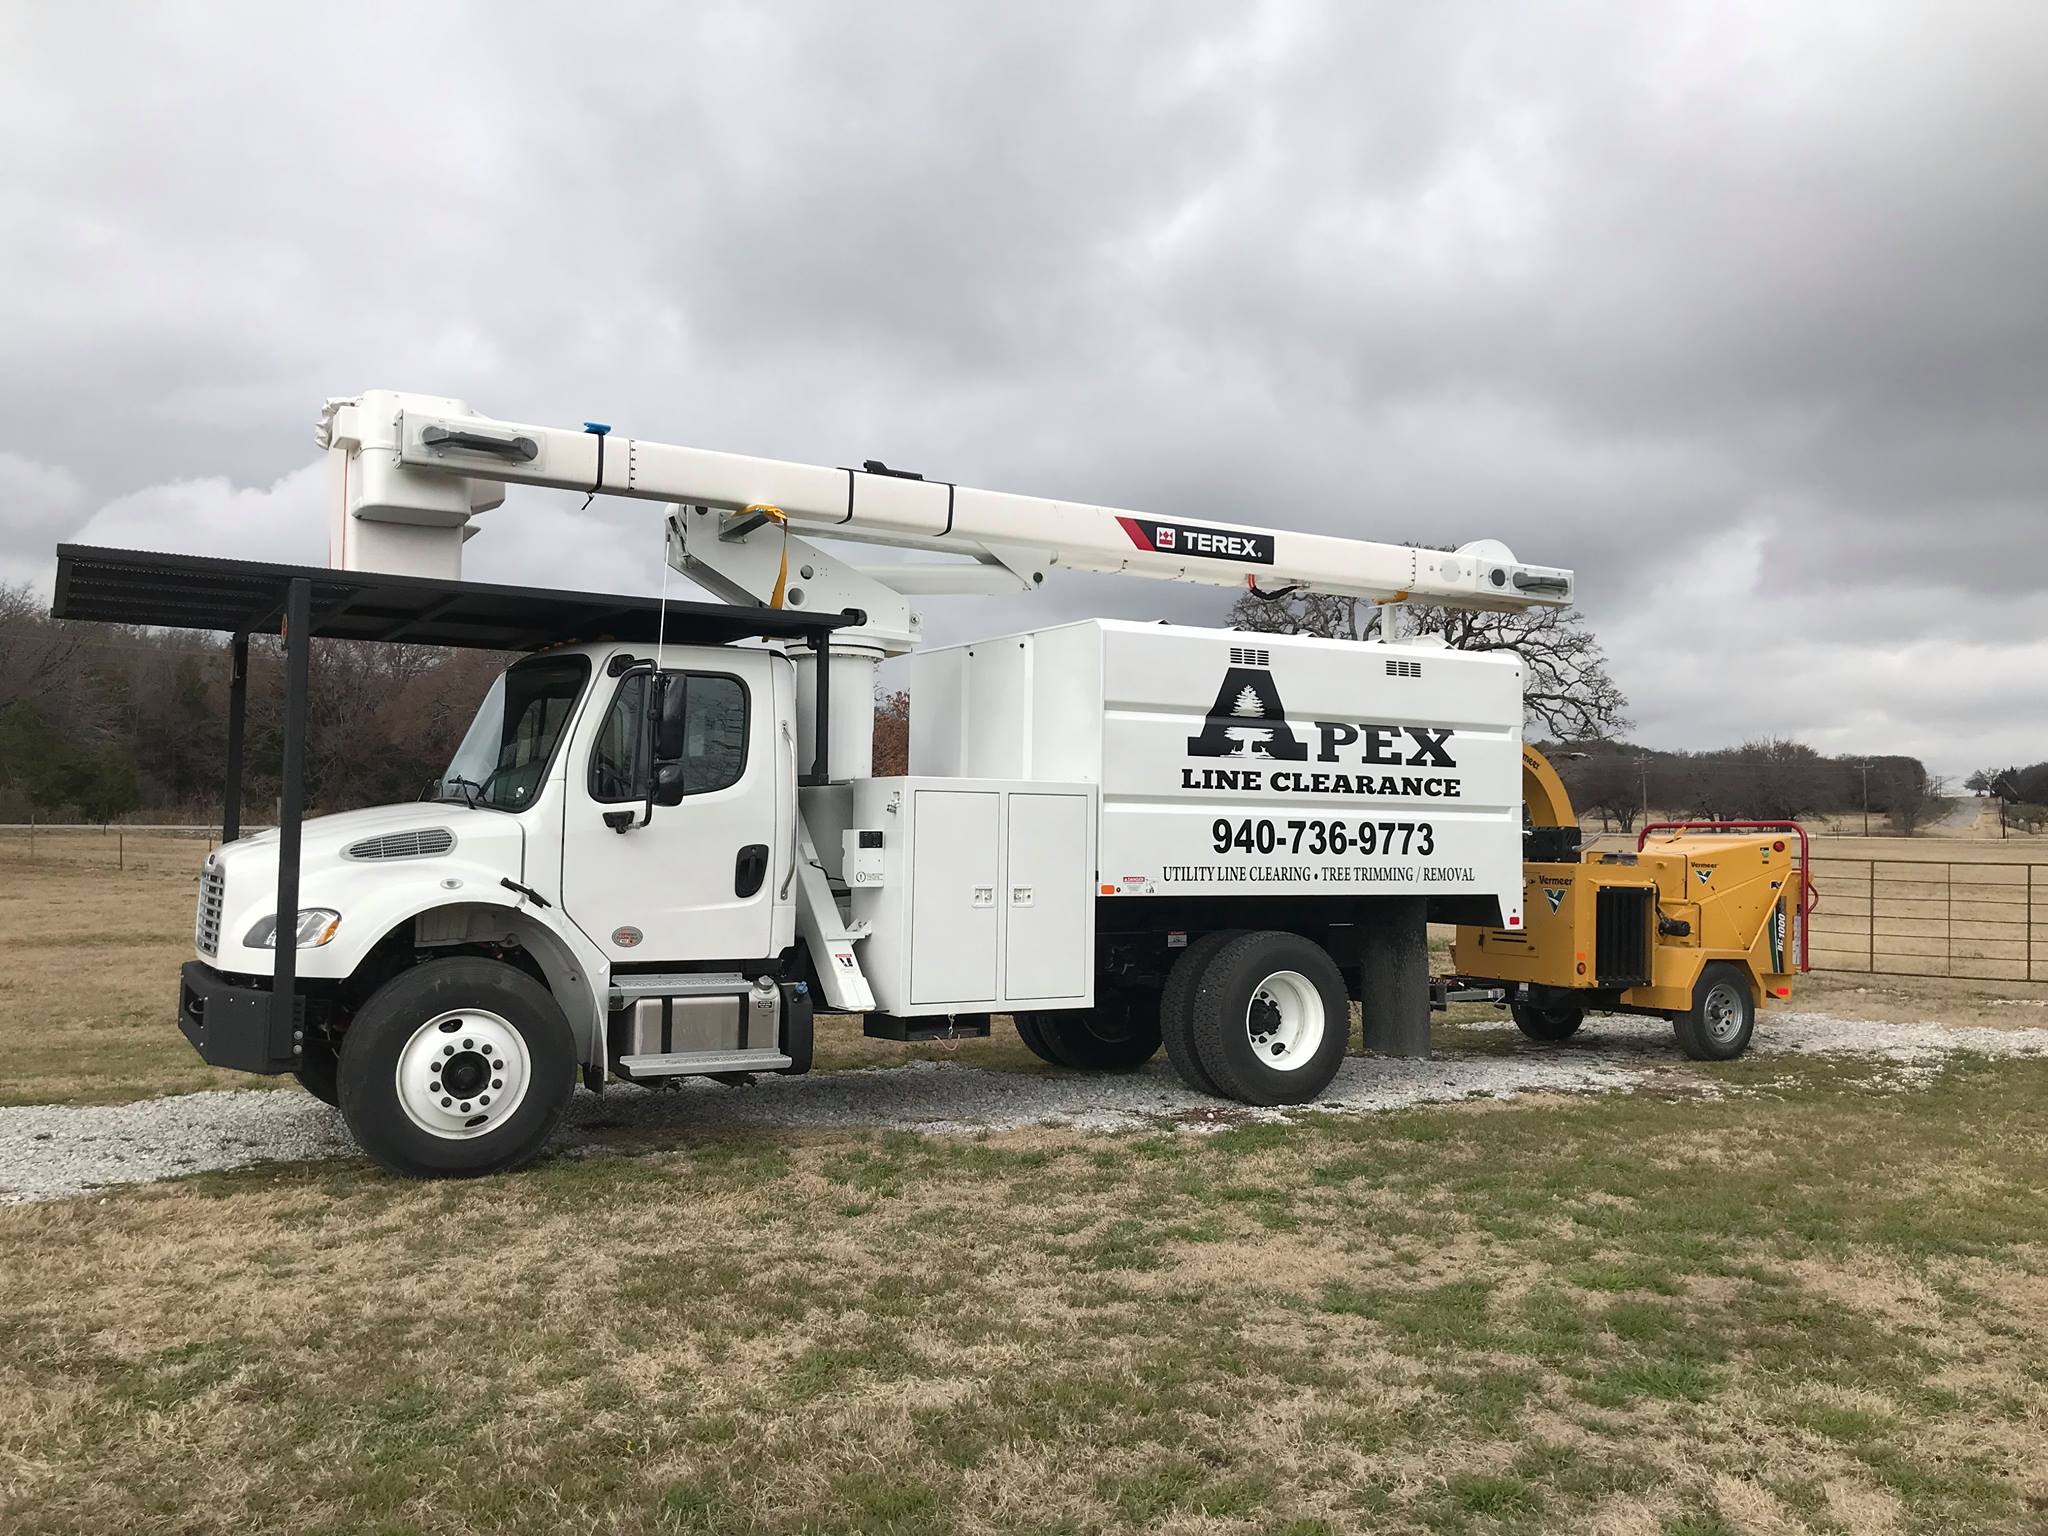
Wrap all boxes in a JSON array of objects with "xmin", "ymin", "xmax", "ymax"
[{"xmin": 317, "ymin": 389, "xmax": 1573, "ymax": 608}]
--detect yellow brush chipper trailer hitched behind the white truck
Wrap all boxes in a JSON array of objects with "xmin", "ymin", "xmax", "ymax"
[{"xmin": 1438, "ymin": 745, "xmax": 1819, "ymax": 1061}]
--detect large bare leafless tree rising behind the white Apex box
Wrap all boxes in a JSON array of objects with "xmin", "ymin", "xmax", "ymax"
[{"xmin": 1231, "ymin": 592, "xmax": 1628, "ymax": 741}]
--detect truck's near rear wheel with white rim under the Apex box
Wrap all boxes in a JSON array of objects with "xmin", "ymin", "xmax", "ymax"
[{"xmin": 1192, "ymin": 932, "xmax": 1352, "ymax": 1106}]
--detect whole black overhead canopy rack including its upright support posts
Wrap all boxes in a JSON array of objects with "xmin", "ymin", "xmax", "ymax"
[{"xmin": 49, "ymin": 545, "xmax": 866, "ymax": 1059}]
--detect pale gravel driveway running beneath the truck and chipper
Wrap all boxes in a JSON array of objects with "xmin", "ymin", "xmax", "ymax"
[{"xmin": 0, "ymin": 1014, "xmax": 2048, "ymax": 1202}]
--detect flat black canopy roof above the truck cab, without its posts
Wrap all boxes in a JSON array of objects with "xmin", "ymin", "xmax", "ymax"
[{"xmin": 51, "ymin": 545, "xmax": 856, "ymax": 651}]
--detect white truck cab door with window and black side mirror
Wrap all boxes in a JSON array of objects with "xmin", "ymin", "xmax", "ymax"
[{"xmin": 561, "ymin": 649, "xmax": 795, "ymax": 963}]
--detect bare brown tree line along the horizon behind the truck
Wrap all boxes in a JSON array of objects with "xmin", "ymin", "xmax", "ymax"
[{"xmin": 0, "ymin": 588, "xmax": 1949, "ymax": 831}]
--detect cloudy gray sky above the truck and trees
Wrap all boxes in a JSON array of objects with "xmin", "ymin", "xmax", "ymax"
[{"xmin": 0, "ymin": 0, "xmax": 2048, "ymax": 774}]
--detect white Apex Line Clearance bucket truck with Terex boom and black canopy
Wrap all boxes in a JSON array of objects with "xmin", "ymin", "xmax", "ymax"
[{"xmin": 57, "ymin": 391, "xmax": 1573, "ymax": 1176}]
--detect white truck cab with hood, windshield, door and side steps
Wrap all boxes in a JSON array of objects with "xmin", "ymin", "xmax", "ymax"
[{"xmin": 186, "ymin": 645, "xmax": 809, "ymax": 1179}]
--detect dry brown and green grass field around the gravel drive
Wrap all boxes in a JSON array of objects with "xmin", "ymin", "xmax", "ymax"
[{"xmin": 0, "ymin": 850, "xmax": 2048, "ymax": 1536}]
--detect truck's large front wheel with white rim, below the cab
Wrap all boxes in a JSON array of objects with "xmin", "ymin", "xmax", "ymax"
[{"xmin": 340, "ymin": 956, "xmax": 575, "ymax": 1178}]
